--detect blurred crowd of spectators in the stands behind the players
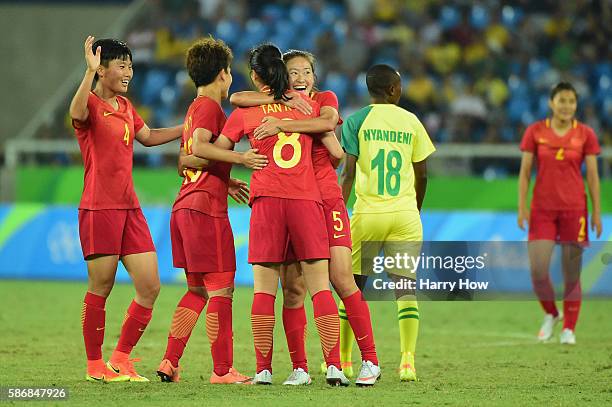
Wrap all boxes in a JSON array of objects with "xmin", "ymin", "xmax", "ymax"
[{"xmin": 41, "ymin": 0, "xmax": 612, "ymax": 166}]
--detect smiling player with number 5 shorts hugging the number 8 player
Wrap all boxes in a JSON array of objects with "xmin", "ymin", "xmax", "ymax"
[{"xmin": 231, "ymin": 50, "xmax": 380, "ymax": 385}]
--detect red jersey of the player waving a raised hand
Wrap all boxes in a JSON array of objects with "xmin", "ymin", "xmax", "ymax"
[{"xmin": 72, "ymin": 92, "xmax": 144, "ymax": 210}]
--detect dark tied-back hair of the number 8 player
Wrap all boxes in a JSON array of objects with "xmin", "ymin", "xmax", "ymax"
[{"xmin": 249, "ymin": 43, "xmax": 289, "ymax": 100}]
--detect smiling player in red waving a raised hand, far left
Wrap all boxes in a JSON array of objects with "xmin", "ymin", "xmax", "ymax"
[{"xmin": 70, "ymin": 36, "xmax": 182, "ymax": 382}]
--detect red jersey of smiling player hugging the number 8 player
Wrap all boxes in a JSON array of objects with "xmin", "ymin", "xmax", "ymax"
[{"xmin": 311, "ymin": 90, "xmax": 342, "ymax": 199}]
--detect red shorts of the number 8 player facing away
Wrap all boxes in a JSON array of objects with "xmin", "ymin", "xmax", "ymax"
[{"xmin": 249, "ymin": 196, "xmax": 329, "ymax": 264}]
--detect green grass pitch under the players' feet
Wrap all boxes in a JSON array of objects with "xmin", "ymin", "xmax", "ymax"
[{"xmin": 0, "ymin": 281, "xmax": 612, "ymax": 407}]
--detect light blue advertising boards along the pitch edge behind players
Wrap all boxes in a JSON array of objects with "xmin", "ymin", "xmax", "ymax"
[{"xmin": 0, "ymin": 204, "xmax": 612, "ymax": 296}]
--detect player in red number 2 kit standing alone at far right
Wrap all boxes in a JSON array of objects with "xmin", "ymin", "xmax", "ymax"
[{"xmin": 518, "ymin": 82, "xmax": 602, "ymax": 345}]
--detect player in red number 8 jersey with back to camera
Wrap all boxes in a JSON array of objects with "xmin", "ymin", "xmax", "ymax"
[{"xmin": 193, "ymin": 44, "xmax": 348, "ymax": 385}]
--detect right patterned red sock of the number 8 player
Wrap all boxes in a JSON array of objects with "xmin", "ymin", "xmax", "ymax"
[{"xmin": 312, "ymin": 290, "xmax": 342, "ymax": 370}]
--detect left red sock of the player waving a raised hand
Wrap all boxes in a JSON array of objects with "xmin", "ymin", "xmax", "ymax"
[{"xmin": 81, "ymin": 292, "xmax": 106, "ymax": 360}]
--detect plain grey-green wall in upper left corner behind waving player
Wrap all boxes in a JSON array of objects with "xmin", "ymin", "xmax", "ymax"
[{"xmin": 0, "ymin": 1, "xmax": 127, "ymax": 146}]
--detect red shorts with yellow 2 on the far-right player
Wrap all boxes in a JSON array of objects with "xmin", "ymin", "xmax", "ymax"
[{"xmin": 529, "ymin": 209, "xmax": 589, "ymax": 244}]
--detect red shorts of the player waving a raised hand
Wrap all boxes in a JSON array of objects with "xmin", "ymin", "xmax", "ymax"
[{"xmin": 79, "ymin": 208, "xmax": 155, "ymax": 260}]
